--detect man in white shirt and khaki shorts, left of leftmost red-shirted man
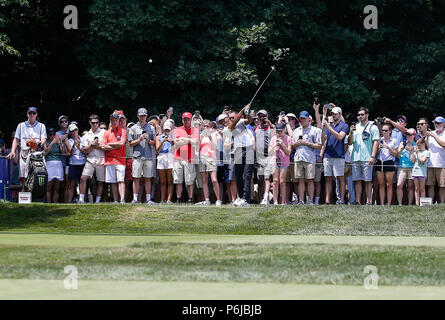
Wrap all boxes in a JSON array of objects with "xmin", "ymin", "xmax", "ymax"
[{"xmin": 79, "ymin": 114, "xmax": 105, "ymax": 203}]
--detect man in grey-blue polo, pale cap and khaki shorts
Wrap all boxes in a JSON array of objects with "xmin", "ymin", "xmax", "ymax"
[{"xmin": 128, "ymin": 108, "xmax": 156, "ymax": 205}]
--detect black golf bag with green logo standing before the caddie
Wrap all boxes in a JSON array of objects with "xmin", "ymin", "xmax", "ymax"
[{"xmin": 25, "ymin": 152, "xmax": 48, "ymax": 201}]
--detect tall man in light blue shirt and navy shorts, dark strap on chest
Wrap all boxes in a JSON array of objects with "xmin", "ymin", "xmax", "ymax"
[{"xmin": 348, "ymin": 107, "xmax": 380, "ymax": 204}]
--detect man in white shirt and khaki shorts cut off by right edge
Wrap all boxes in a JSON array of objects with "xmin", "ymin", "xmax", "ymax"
[{"xmin": 426, "ymin": 117, "xmax": 445, "ymax": 203}]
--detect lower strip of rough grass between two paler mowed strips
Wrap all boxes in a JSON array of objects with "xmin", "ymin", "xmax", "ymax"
[{"xmin": 0, "ymin": 243, "xmax": 445, "ymax": 286}]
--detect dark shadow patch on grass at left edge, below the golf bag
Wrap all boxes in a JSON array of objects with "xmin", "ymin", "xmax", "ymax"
[{"xmin": 0, "ymin": 205, "xmax": 75, "ymax": 231}]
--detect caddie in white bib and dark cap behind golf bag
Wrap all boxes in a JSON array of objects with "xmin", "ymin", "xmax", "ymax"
[{"xmin": 7, "ymin": 107, "xmax": 47, "ymax": 191}]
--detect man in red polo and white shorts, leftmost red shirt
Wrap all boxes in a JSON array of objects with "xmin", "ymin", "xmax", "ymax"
[{"xmin": 102, "ymin": 112, "xmax": 127, "ymax": 203}]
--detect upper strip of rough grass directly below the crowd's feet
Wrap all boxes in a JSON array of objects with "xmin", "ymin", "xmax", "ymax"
[{"xmin": 0, "ymin": 204, "xmax": 445, "ymax": 237}]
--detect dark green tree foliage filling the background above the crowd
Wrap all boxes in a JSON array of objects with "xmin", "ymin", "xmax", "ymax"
[{"xmin": 0, "ymin": 0, "xmax": 445, "ymax": 136}]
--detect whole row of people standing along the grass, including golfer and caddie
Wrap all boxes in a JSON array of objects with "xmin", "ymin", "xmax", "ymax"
[{"xmin": 4, "ymin": 103, "xmax": 445, "ymax": 206}]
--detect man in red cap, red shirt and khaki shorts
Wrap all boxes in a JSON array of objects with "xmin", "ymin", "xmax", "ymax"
[{"xmin": 173, "ymin": 112, "xmax": 199, "ymax": 204}]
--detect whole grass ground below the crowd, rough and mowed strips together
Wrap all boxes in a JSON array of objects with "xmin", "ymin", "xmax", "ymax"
[{"xmin": 0, "ymin": 204, "xmax": 445, "ymax": 299}]
